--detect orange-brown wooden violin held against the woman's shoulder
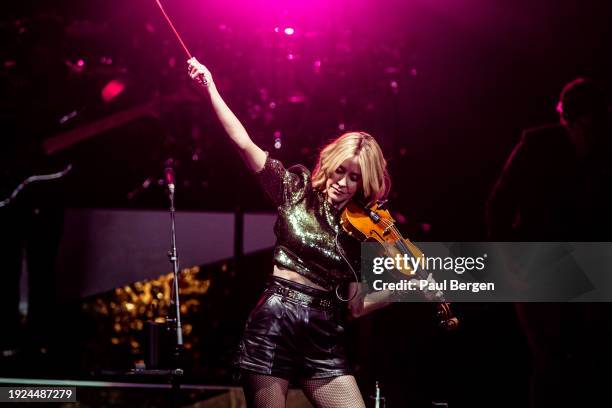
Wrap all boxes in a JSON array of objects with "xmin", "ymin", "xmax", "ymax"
[{"xmin": 340, "ymin": 200, "xmax": 459, "ymax": 330}]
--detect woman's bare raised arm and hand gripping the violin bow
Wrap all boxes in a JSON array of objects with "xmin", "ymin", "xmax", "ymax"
[{"xmin": 187, "ymin": 58, "xmax": 266, "ymax": 172}]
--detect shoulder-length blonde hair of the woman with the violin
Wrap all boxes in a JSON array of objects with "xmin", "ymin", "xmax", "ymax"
[{"xmin": 312, "ymin": 132, "xmax": 391, "ymax": 203}]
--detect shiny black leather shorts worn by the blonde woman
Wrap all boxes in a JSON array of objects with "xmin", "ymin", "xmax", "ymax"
[{"xmin": 234, "ymin": 276, "xmax": 350, "ymax": 381}]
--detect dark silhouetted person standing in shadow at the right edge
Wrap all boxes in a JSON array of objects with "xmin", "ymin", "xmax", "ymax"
[{"xmin": 487, "ymin": 78, "xmax": 612, "ymax": 407}]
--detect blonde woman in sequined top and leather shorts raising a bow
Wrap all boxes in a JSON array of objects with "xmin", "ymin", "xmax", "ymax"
[{"xmin": 188, "ymin": 58, "xmax": 426, "ymax": 408}]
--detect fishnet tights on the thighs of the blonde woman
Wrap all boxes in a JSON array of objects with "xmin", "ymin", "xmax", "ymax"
[{"xmin": 244, "ymin": 374, "xmax": 365, "ymax": 408}]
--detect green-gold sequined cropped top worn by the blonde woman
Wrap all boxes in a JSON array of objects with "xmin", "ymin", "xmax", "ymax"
[{"xmin": 255, "ymin": 154, "xmax": 360, "ymax": 290}]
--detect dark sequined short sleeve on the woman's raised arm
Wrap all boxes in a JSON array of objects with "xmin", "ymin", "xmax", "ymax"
[{"xmin": 255, "ymin": 152, "xmax": 310, "ymax": 206}]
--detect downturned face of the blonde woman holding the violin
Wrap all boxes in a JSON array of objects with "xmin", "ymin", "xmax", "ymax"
[{"xmin": 325, "ymin": 156, "xmax": 361, "ymax": 208}]
